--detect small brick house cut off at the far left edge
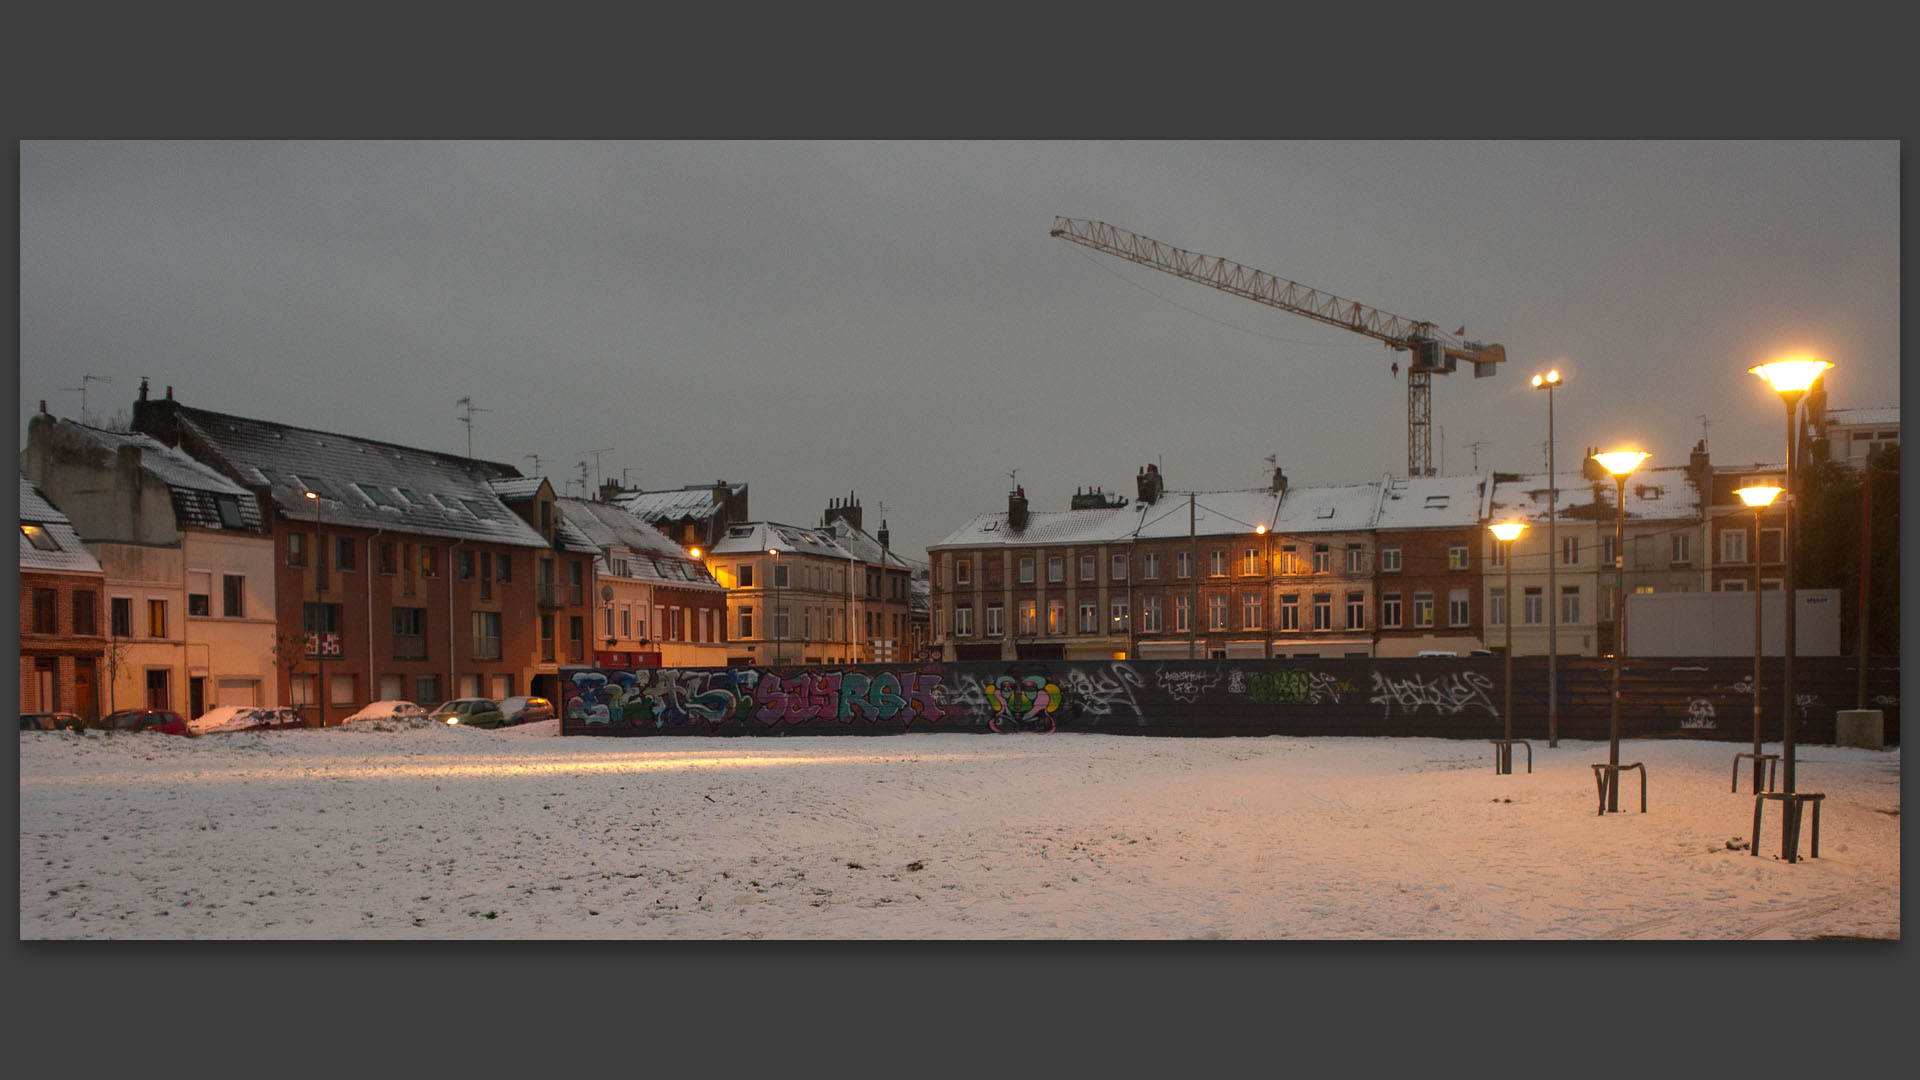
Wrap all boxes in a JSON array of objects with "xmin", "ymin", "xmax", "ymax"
[{"xmin": 19, "ymin": 477, "xmax": 106, "ymax": 721}]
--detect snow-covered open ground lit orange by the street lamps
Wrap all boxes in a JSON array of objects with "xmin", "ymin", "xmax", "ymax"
[{"xmin": 19, "ymin": 721, "xmax": 1901, "ymax": 940}]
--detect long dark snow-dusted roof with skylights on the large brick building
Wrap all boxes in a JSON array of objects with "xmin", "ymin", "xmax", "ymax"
[{"xmin": 156, "ymin": 402, "xmax": 547, "ymax": 548}]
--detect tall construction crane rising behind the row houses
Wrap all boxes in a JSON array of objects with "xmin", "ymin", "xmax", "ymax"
[{"xmin": 1052, "ymin": 217, "xmax": 1507, "ymax": 477}]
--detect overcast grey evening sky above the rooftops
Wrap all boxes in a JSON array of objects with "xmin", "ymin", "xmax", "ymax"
[{"xmin": 19, "ymin": 140, "xmax": 1899, "ymax": 557}]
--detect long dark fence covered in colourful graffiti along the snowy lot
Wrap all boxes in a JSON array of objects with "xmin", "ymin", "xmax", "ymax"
[{"xmin": 561, "ymin": 657, "xmax": 1899, "ymax": 744}]
